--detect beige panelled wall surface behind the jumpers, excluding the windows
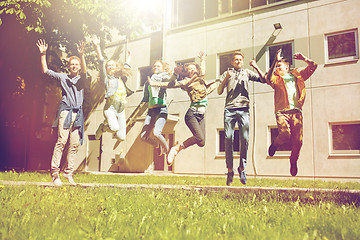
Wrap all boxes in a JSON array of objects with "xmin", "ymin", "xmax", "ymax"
[{"xmin": 74, "ymin": 0, "xmax": 360, "ymax": 178}]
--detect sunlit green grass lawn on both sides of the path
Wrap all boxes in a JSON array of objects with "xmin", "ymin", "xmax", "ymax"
[{"xmin": 0, "ymin": 172, "xmax": 360, "ymax": 240}]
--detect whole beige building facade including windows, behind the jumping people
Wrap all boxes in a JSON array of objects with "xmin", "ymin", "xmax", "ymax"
[{"xmin": 74, "ymin": 0, "xmax": 360, "ymax": 179}]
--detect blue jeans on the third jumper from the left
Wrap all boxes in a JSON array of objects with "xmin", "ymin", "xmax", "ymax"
[{"xmin": 140, "ymin": 107, "xmax": 169, "ymax": 152}]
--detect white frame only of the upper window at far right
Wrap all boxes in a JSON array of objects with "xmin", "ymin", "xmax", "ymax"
[{"xmin": 324, "ymin": 28, "xmax": 359, "ymax": 64}]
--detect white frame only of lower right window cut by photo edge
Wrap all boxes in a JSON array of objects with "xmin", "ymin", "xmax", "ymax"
[{"xmin": 328, "ymin": 121, "xmax": 360, "ymax": 158}]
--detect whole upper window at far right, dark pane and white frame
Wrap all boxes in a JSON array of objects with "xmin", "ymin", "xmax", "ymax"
[{"xmin": 325, "ymin": 29, "xmax": 359, "ymax": 63}]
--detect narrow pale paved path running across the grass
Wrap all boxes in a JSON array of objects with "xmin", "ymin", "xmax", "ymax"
[{"xmin": 0, "ymin": 180, "xmax": 360, "ymax": 199}]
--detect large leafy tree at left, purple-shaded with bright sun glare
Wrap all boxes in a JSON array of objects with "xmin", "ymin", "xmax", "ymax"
[{"xmin": 0, "ymin": 0, "xmax": 162, "ymax": 169}]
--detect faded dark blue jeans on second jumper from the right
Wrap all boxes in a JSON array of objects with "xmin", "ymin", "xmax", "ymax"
[{"xmin": 224, "ymin": 108, "xmax": 250, "ymax": 171}]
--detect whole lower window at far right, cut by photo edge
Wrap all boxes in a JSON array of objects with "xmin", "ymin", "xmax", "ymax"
[{"xmin": 330, "ymin": 123, "xmax": 360, "ymax": 154}]
